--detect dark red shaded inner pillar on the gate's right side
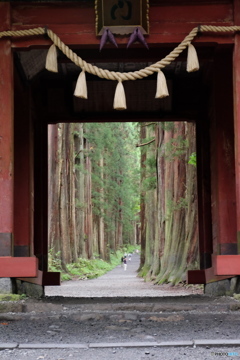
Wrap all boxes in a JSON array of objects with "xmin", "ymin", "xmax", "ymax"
[{"xmin": 211, "ymin": 48, "xmax": 237, "ymax": 256}]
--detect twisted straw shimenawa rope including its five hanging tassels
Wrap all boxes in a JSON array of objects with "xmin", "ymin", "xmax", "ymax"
[{"xmin": 0, "ymin": 25, "xmax": 240, "ymax": 110}]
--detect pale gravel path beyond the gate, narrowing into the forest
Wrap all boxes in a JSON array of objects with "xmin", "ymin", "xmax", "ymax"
[{"xmin": 45, "ymin": 254, "xmax": 202, "ymax": 298}]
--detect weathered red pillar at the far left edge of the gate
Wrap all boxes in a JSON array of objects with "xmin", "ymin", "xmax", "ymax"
[{"xmin": 0, "ymin": 3, "xmax": 13, "ymax": 256}]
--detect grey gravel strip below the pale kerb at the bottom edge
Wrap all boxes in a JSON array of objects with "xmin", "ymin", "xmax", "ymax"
[{"xmin": 1, "ymin": 347, "xmax": 240, "ymax": 360}]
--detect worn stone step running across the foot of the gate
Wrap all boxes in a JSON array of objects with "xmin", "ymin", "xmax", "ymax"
[{"xmin": 0, "ymin": 295, "xmax": 240, "ymax": 316}]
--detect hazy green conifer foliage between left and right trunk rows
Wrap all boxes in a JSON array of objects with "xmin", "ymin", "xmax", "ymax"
[{"xmin": 84, "ymin": 123, "xmax": 140, "ymax": 241}]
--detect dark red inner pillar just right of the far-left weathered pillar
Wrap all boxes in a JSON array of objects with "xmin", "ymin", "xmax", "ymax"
[{"xmin": 13, "ymin": 69, "xmax": 33, "ymax": 257}]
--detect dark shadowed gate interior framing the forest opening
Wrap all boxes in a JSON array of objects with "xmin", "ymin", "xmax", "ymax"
[{"xmin": 14, "ymin": 45, "xmax": 237, "ymax": 285}]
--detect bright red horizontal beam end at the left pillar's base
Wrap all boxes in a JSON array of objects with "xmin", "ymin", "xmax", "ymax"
[{"xmin": 0, "ymin": 256, "xmax": 38, "ymax": 277}]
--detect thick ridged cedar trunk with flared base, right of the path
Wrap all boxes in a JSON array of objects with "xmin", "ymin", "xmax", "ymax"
[{"xmin": 141, "ymin": 122, "xmax": 198, "ymax": 284}]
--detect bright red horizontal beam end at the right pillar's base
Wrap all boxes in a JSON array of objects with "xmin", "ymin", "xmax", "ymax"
[{"xmin": 212, "ymin": 255, "xmax": 240, "ymax": 276}]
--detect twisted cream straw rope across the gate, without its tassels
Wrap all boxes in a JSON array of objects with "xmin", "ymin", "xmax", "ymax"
[{"xmin": 0, "ymin": 25, "xmax": 240, "ymax": 81}]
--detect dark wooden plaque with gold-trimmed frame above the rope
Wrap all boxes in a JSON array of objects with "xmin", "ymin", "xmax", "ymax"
[{"xmin": 95, "ymin": 0, "xmax": 149, "ymax": 35}]
